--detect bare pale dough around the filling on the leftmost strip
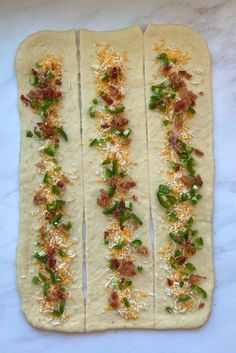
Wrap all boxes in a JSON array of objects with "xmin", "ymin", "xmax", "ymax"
[{"xmin": 15, "ymin": 30, "xmax": 84, "ymax": 332}]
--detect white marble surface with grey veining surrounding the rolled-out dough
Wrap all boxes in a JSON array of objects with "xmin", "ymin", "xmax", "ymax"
[{"xmin": 0, "ymin": 0, "xmax": 236, "ymax": 353}]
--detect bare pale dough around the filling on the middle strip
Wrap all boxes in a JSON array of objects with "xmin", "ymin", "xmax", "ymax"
[{"xmin": 80, "ymin": 26, "xmax": 154, "ymax": 331}]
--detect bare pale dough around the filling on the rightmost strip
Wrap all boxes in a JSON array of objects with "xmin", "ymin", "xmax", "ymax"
[{"xmin": 144, "ymin": 24, "xmax": 214, "ymax": 329}]
